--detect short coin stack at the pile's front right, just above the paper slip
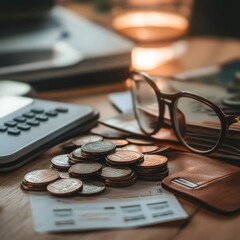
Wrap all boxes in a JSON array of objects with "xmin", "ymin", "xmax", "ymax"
[{"xmin": 99, "ymin": 166, "xmax": 137, "ymax": 187}]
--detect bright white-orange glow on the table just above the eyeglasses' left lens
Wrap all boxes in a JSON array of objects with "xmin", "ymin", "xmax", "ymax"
[{"xmin": 132, "ymin": 41, "xmax": 187, "ymax": 70}]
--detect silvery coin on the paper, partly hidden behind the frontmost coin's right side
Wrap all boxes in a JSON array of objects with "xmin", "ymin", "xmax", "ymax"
[{"xmin": 78, "ymin": 180, "xmax": 106, "ymax": 196}]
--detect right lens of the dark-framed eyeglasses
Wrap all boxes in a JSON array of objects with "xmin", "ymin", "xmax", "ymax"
[{"xmin": 174, "ymin": 97, "xmax": 221, "ymax": 151}]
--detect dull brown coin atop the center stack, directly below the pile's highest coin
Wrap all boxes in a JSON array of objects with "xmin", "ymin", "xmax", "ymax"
[{"xmin": 68, "ymin": 162, "xmax": 102, "ymax": 176}]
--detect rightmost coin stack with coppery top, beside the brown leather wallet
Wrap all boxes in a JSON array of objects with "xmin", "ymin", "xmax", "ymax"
[{"xmin": 134, "ymin": 155, "xmax": 168, "ymax": 181}]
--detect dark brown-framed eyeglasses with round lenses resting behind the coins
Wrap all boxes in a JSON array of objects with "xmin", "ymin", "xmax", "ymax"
[{"xmin": 131, "ymin": 72, "xmax": 240, "ymax": 153}]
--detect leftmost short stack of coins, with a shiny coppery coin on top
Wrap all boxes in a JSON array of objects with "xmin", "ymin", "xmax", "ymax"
[{"xmin": 21, "ymin": 169, "xmax": 59, "ymax": 191}]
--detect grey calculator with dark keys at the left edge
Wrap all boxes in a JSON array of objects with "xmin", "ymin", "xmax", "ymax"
[{"xmin": 0, "ymin": 96, "xmax": 99, "ymax": 172}]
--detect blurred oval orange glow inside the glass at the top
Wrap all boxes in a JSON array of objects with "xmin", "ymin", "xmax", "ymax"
[{"xmin": 112, "ymin": 11, "xmax": 188, "ymax": 41}]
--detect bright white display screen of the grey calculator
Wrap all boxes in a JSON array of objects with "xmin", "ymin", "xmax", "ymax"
[{"xmin": 0, "ymin": 96, "xmax": 33, "ymax": 119}]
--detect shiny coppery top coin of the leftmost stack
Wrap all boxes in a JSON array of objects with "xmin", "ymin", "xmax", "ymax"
[{"xmin": 24, "ymin": 169, "xmax": 59, "ymax": 185}]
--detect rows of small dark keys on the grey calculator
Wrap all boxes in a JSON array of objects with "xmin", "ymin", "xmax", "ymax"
[{"xmin": 0, "ymin": 107, "xmax": 68, "ymax": 135}]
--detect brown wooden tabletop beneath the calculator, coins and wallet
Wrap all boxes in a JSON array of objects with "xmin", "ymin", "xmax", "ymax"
[{"xmin": 0, "ymin": 6, "xmax": 240, "ymax": 240}]
